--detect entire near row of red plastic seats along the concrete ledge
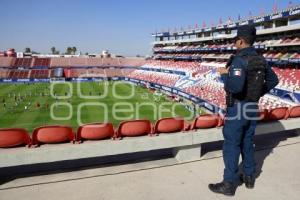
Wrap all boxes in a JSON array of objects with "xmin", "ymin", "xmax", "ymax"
[{"xmin": 0, "ymin": 106, "xmax": 300, "ymax": 148}]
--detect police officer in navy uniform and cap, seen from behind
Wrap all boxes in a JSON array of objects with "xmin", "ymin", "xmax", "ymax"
[{"xmin": 209, "ymin": 26, "xmax": 278, "ymax": 196}]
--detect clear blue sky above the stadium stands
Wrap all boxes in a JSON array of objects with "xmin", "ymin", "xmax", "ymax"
[{"xmin": 0, "ymin": 0, "xmax": 300, "ymax": 56}]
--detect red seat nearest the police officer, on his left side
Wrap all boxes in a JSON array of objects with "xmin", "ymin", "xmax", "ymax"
[{"xmin": 192, "ymin": 114, "xmax": 221, "ymax": 129}]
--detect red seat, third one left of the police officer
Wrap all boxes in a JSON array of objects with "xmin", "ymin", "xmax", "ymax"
[{"xmin": 115, "ymin": 120, "xmax": 152, "ymax": 138}]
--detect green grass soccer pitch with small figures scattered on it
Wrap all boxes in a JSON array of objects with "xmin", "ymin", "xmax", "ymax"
[{"xmin": 0, "ymin": 82, "xmax": 202, "ymax": 132}]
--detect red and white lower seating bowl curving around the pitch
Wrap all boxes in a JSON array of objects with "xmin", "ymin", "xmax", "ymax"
[{"xmin": 0, "ymin": 56, "xmax": 300, "ymax": 115}]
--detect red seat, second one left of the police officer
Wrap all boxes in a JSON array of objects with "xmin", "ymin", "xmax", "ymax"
[{"xmin": 154, "ymin": 118, "xmax": 185, "ymax": 134}]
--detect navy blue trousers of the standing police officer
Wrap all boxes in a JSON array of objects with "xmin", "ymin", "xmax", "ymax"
[{"xmin": 223, "ymin": 102, "xmax": 258, "ymax": 183}]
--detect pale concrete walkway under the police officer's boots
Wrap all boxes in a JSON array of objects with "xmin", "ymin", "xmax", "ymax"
[{"xmin": 0, "ymin": 133, "xmax": 300, "ymax": 200}]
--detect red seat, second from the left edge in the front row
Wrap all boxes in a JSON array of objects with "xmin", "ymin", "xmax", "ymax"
[{"xmin": 32, "ymin": 126, "xmax": 75, "ymax": 145}]
